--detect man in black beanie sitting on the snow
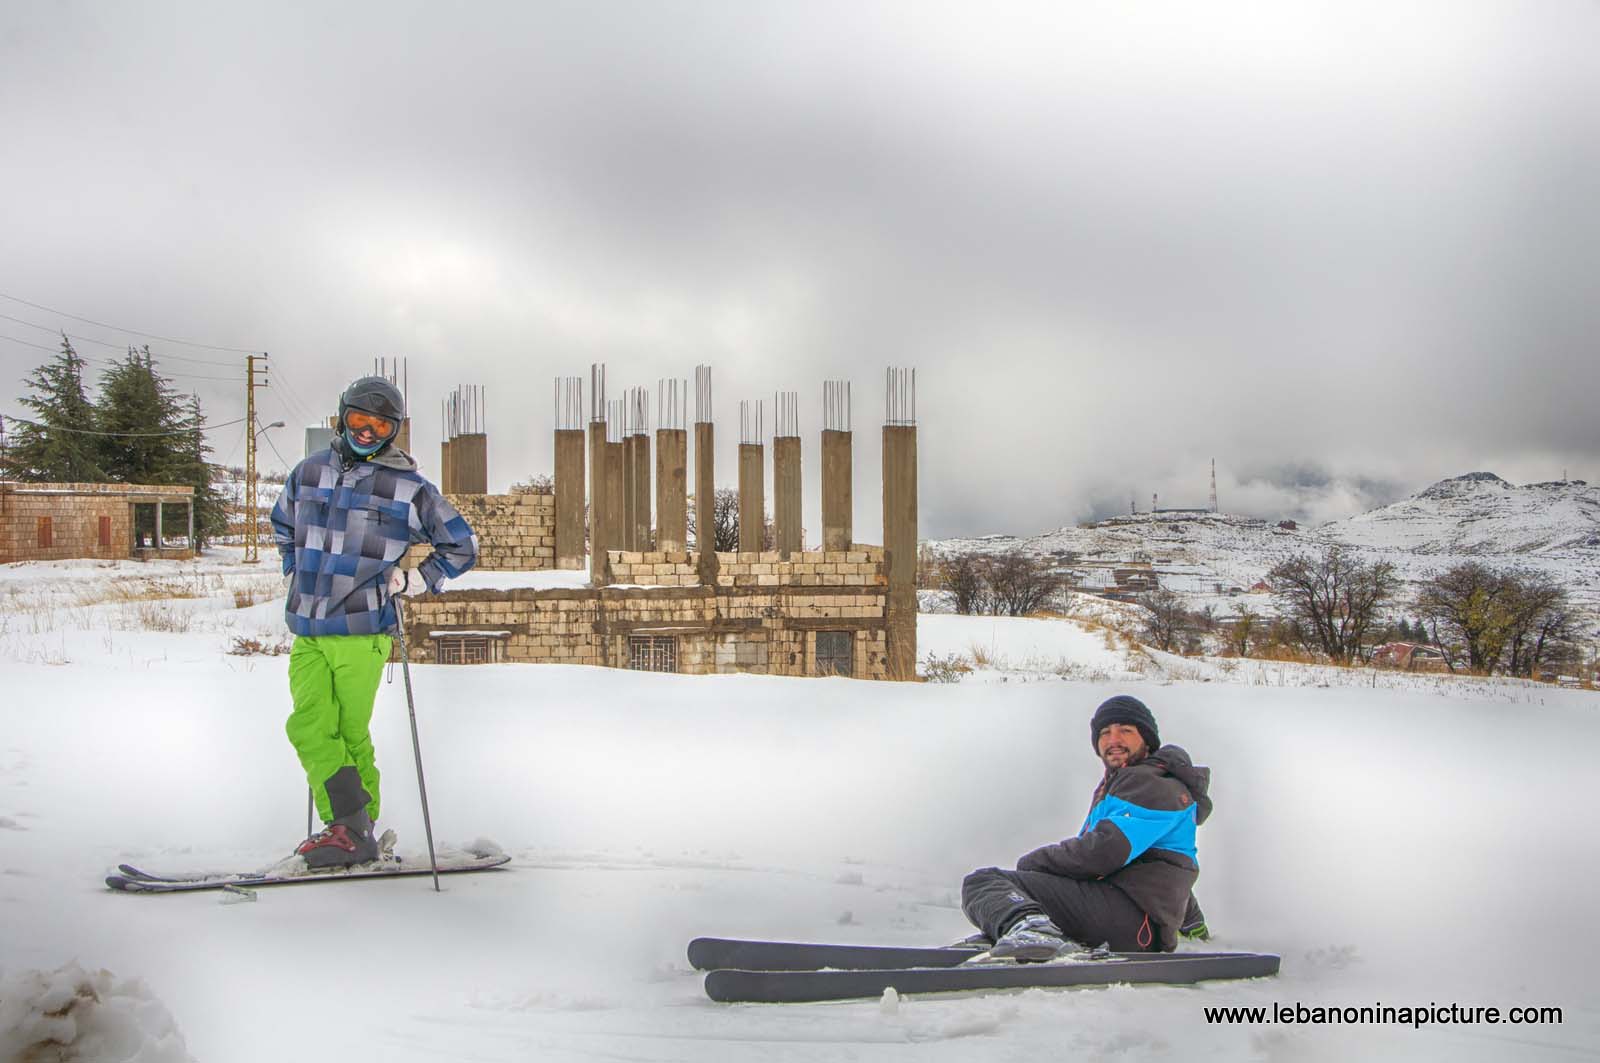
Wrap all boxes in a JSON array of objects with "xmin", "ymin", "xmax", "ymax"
[{"xmin": 962, "ymin": 695, "xmax": 1211, "ymax": 961}]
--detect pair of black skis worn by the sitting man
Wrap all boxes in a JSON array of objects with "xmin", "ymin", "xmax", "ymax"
[{"xmin": 690, "ymin": 938, "xmax": 1278, "ymax": 1004}]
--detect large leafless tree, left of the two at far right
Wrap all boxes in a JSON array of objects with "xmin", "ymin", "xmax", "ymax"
[{"xmin": 1267, "ymin": 546, "xmax": 1400, "ymax": 664}]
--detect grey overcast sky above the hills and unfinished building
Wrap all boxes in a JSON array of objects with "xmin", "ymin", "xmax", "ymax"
[{"xmin": 0, "ymin": 0, "xmax": 1600, "ymax": 541}]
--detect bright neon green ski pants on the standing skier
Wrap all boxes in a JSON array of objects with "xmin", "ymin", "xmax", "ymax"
[{"xmin": 283, "ymin": 636, "xmax": 394, "ymax": 823}]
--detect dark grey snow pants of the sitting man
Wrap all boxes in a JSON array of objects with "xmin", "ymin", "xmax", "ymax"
[{"xmin": 962, "ymin": 868, "xmax": 1160, "ymax": 953}]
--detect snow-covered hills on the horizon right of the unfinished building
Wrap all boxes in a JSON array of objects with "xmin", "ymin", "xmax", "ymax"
[{"xmin": 928, "ymin": 472, "xmax": 1600, "ymax": 616}]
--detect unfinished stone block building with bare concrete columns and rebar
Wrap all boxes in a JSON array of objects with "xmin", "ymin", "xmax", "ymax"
[{"xmin": 406, "ymin": 365, "xmax": 917, "ymax": 679}]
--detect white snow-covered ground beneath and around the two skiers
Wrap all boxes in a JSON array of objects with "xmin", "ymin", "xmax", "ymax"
[{"xmin": 0, "ymin": 554, "xmax": 1600, "ymax": 1063}]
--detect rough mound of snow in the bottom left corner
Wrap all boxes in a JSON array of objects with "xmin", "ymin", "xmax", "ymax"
[{"xmin": 0, "ymin": 964, "xmax": 194, "ymax": 1063}]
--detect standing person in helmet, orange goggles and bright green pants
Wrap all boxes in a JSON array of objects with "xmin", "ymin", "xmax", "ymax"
[{"xmin": 272, "ymin": 376, "xmax": 478, "ymax": 868}]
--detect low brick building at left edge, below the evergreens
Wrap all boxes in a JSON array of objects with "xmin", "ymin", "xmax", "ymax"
[{"xmin": 0, "ymin": 480, "xmax": 194, "ymax": 565}]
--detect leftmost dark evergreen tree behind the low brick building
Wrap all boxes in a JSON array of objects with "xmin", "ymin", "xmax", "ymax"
[{"xmin": 0, "ymin": 333, "xmax": 106, "ymax": 483}]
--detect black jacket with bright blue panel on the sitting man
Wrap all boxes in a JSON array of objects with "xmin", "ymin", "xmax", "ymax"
[{"xmin": 1016, "ymin": 746, "xmax": 1211, "ymax": 951}]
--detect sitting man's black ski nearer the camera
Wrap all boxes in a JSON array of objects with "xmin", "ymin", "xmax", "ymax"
[{"xmin": 706, "ymin": 953, "xmax": 1278, "ymax": 1004}]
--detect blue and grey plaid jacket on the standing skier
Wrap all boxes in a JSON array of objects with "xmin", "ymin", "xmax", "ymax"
[{"xmin": 272, "ymin": 447, "xmax": 478, "ymax": 636}]
